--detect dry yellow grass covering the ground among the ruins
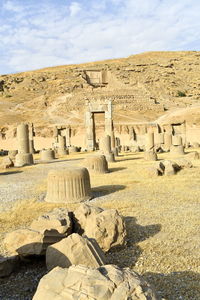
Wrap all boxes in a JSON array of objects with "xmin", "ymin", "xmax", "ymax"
[{"xmin": 0, "ymin": 153, "xmax": 200, "ymax": 300}]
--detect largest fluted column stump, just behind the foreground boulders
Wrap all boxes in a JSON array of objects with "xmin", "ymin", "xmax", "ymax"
[{"xmin": 45, "ymin": 167, "xmax": 92, "ymax": 203}]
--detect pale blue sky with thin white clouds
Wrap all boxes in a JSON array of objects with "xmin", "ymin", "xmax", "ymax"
[{"xmin": 0, "ymin": 0, "xmax": 200, "ymax": 74}]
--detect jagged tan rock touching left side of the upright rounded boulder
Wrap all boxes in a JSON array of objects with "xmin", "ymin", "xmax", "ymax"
[{"xmin": 30, "ymin": 208, "xmax": 72, "ymax": 238}]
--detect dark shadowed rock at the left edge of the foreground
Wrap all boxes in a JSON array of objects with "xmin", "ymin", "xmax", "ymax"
[{"xmin": 0, "ymin": 255, "xmax": 19, "ymax": 277}]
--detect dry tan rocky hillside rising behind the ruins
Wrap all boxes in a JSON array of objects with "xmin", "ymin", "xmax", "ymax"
[{"xmin": 0, "ymin": 52, "xmax": 200, "ymax": 137}]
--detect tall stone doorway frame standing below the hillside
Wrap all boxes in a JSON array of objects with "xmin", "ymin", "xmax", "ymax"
[{"xmin": 85, "ymin": 100, "xmax": 113, "ymax": 151}]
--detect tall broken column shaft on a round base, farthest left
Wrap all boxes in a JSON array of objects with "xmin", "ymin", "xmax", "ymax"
[{"xmin": 15, "ymin": 123, "xmax": 33, "ymax": 167}]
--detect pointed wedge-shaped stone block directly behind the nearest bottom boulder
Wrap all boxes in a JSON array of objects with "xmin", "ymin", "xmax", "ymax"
[{"xmin": 46, "ymin": 233, "xmax": 105, "ymax": 270}]
